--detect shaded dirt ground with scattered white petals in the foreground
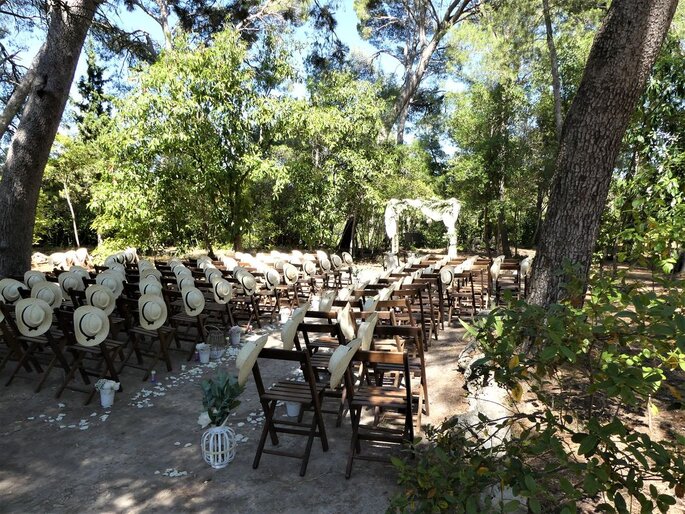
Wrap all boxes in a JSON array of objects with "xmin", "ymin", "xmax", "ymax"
[{"xmin": 0, "ymin": 316, "xmax": 466, "ymax": 513}]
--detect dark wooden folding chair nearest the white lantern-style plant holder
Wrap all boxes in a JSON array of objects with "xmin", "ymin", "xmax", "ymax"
[{"xmin": 252, "ymin": 348, "xmax": 328, "ymax": 476}]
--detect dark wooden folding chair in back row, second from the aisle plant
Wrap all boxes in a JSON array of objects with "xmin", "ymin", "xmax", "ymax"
[{"xmin": 345, "ymin": 350, "xmax": 414, "ymax": 478}]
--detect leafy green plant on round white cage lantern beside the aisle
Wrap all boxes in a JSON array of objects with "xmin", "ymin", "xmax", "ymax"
[{"xmin": 198, "ymin": 371, "xmax": 244, "ymax": 469}]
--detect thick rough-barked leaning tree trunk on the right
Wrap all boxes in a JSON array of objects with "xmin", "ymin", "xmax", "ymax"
[{"xmin": 529, "ymin": 0, "xmax": 678, "ymax": 305}]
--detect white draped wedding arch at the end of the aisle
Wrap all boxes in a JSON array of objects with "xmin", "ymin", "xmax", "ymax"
[{"xmin": 385, "ymin": 198, "xmax": 461, "ymax": 257}]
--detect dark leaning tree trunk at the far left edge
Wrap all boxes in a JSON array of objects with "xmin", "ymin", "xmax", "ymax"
[{"xmin": 0, "ymin": 0, "xmax": 99, "ymax": 276}]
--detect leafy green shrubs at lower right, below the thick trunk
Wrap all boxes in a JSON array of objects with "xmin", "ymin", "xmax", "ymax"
[{"xmin": 391, "ymin": 270, "xmax": 685, "ymax": 513}]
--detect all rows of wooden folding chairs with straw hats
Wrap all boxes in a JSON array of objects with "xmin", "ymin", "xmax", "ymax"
[{"xmin": 0, "ymin": 249, "xmax": 530, "ymax": 478}]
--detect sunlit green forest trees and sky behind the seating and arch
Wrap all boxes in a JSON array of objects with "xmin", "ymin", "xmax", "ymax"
[{"xmin": 1, "ymin": 0, "xmax": 685, "ymax": 268}]
